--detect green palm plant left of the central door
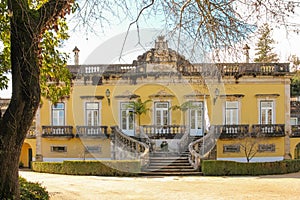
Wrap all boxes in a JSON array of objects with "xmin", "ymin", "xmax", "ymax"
[{"xmin": 127, "ymin": 98, "xmax": 151, "ymax": 126}]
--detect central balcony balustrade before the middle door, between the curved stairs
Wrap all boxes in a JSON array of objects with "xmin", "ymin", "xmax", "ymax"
[{"xmin": 142, "ymin": 125, "xmax": 186, "ymax": 139}]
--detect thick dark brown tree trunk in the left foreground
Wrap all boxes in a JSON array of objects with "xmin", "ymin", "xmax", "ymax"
[{"xmin": 0, "ymin": 3, "xmax": 40, "ymax": 199}]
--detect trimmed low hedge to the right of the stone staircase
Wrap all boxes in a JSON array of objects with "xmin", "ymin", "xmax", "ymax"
[{"xmin": 201, "ymin": 160, "xmax": 300, "ymax": 176}]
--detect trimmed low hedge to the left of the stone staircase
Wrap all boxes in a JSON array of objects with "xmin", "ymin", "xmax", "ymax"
[{"xmin": 32, "ymin": 160, "xmax": 141, "ymax": 176}]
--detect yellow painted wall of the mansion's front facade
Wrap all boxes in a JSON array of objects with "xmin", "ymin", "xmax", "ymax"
[{"xmin": 34, "ymin": 74, "xmax": 288, "ymax": 161}]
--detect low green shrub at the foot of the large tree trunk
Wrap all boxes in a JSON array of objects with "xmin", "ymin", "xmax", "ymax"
[{"xmin": 19, "ymin": 177, "xmax": 49, "ymax": 200}]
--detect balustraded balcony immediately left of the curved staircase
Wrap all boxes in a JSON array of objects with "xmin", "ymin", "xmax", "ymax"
[{"xmin": 76, "ymin": 126, "xmax": 109, "ymax": 138}]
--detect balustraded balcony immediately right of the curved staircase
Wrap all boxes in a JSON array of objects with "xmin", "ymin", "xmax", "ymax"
[{"xmin": 215, "ymin": 124, "xmax": 249, "ymax": 139}]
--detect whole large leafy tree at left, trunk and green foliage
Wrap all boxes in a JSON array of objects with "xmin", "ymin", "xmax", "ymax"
[{"xmin": 0, "ymin": 0, "xmax": 72, "ymax": 199}]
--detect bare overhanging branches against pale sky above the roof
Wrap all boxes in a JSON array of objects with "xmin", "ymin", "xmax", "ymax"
[{"xmin": 74, "ymin": 0, "xmax": 299, "ymax": 59}]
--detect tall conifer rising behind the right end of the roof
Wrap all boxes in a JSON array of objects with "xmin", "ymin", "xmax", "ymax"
[{"xmin": 254, "ymin": 24, "xmax": 279, "ymax": 63}]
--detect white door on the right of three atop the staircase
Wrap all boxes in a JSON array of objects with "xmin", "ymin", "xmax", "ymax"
[{"xmin": 189, "ymin": 102, "xmax": 203, "ymax": 136}]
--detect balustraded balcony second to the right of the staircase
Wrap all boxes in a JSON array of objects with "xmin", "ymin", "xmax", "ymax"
[{"xmin": 252, "ymin": 124, "xmax": 285, "ymax": 137}]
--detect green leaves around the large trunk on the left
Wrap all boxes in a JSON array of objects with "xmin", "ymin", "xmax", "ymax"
[{"xmin": 0, "ymin": 0, "xmax": 71, "ymax": 103}]
